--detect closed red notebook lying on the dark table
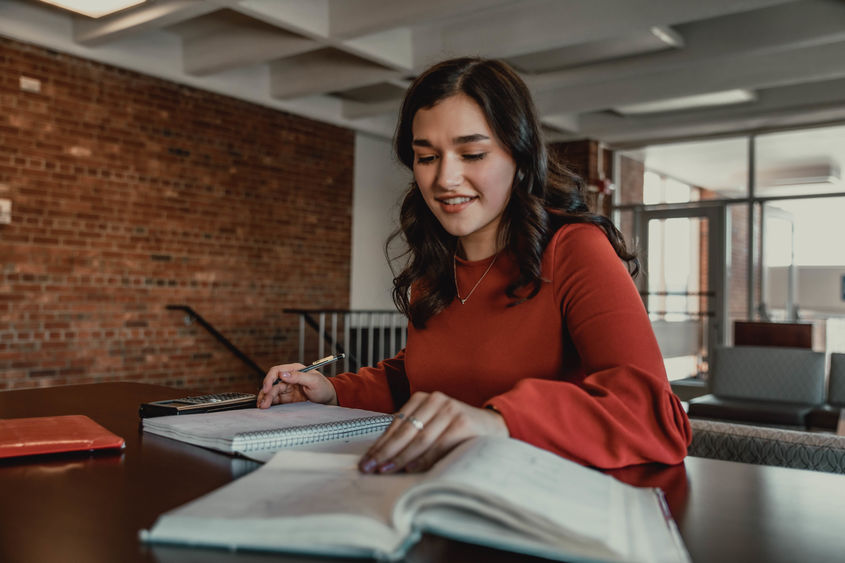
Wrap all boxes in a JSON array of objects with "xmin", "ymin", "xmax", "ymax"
[{"xmin": 0, "ymin": 414, "xmax": 124, "ymax": 458}]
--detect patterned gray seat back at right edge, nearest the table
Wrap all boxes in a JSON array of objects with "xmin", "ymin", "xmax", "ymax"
[{"xmin": 687, "ymin": 419, "xmax": 845, "ymax": 473}]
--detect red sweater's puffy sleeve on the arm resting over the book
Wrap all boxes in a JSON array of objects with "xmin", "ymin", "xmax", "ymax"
[{"xmin": 485, "ymin": 224, "xmax": 692, "ymax": 469}]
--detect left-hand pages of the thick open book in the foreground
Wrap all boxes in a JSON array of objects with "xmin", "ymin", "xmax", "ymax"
[{"xmin": 144, "ymin": 450, "xmax": 422, "ymax": 555}]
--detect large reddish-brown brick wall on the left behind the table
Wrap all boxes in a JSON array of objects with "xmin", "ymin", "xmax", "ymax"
[{"xmin": 0, "ymin": 39, "xmax": 354, "ymax": 391}]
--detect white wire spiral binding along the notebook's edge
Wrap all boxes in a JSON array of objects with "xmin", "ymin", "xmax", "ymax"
[{"xmin": 232, "ymin": 415, "xmax": 393, "ymax": 452}]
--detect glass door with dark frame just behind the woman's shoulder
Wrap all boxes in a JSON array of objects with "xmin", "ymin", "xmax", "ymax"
[{"xmin": 635, "ymin": 205, "xmax": 728, "ymax": 381}]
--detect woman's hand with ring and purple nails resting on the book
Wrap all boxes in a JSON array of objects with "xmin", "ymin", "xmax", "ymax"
[{"xmin": 358, "ymin": 392, "xmax": 509, "ymax": 473}]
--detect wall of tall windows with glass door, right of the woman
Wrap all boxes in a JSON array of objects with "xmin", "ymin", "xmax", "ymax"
[{"xmin": 614, "ymin": 125, "xmax": 845, "ymax": 379}]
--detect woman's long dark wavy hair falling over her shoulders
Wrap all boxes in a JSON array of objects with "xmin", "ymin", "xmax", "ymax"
[{"xmin": 385, "ymin": 57, "xmax": 639, "ymax": 328}]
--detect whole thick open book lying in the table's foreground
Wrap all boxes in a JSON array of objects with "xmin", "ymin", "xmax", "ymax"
[{"xmin": 141, "ymin": 437, "xmax": 689, "ymax": 563}]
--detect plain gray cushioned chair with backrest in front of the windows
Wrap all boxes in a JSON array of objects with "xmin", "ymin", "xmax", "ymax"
[{"xmin": 689, "ymin": 346, "xmax": 825, "ymax": 428}]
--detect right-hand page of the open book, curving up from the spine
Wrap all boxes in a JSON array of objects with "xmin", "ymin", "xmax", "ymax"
[{"xmin": 405, "ymin": 438, "xmax": 628, "ymax": 557}]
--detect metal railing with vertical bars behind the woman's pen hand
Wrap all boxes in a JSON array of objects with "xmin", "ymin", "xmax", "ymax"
[{"xmin": 284, "ymin": 309, "xmax": 408, "ymax": 375}]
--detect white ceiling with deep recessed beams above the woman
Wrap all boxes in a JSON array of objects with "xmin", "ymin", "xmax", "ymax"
[{"xmin": 0, "ymin": 0, "xmax": 845, "ymax": 189}]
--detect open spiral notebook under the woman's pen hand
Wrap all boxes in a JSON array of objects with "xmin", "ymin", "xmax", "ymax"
[{"xmin": 142, "ymin": 402, "xmax": 393, "ymax": 460}]
